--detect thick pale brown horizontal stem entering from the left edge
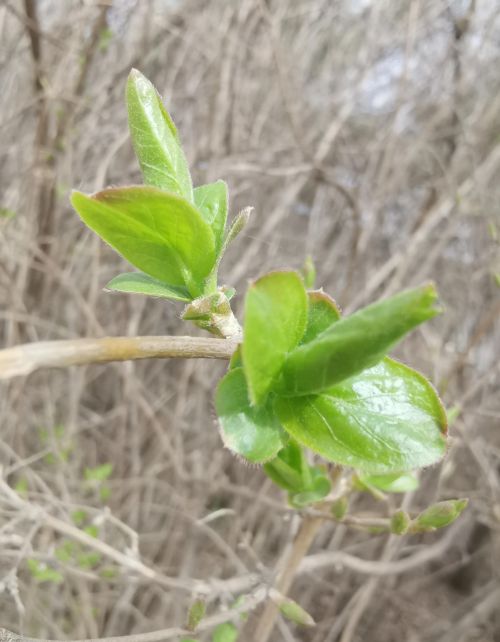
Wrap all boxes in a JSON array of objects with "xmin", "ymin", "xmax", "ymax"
[{"xmin": 0, "ymin": 336, "xmax": 238, "ymax": 379}]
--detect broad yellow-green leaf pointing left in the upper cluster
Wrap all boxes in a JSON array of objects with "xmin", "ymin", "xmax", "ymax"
[{"xmin": 71, "ymin": 186, "xmax": 215, "ymax": 296}]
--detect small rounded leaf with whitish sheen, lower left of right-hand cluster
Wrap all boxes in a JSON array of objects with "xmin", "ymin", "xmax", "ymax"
[{"xmin": 215, "ymin": 368, "xmax": 283, "ymax": 463}]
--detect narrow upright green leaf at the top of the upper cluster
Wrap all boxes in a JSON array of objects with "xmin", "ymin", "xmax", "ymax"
[{"xmin": 126, "ymin": 69, "xmax": 193, "ymax": 201}]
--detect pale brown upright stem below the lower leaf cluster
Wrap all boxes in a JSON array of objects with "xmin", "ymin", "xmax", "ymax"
[{"xmin": 254, "ymin": 517, "xmax": 324, "ymax": 642}]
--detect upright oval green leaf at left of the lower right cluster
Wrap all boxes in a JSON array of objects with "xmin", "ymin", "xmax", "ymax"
[{"xmin": 242, "ymin": 272, "xmax": 307, "ymax": 404}]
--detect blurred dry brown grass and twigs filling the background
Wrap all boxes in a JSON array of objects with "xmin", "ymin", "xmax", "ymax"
[{"xmin": 0, "ymin": 0, "xmax": 500, "ymax": 642}]
